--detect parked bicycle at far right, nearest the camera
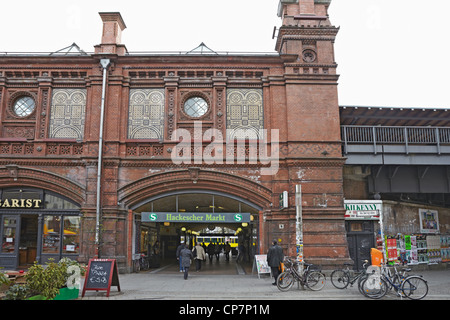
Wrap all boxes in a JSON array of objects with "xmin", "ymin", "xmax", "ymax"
[{"xmin": 361, "ymin": 265, "xmax": 428, "ymax": 300}]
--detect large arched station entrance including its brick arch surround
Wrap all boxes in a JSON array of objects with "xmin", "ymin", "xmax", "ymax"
[{"xmin": 119, "ymin": 168, "xmax": 270, "ymax": 271}]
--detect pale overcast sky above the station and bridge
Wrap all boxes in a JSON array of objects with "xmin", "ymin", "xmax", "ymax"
[{"xmin": 0, "ymin": 0, "xmax": 450, "ymax": 108}]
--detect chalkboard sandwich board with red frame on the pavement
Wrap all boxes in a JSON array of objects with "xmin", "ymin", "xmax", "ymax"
[{"xmin": 81, "ymin": 259, "xmax": 120, "ymax": 297}]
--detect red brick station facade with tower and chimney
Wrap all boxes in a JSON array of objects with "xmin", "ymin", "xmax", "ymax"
[{"xmin": 0, "ymin": 0, "xmax": 348, "ymax": 267}]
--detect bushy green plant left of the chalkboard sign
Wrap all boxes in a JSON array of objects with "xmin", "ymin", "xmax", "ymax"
[{"xmin": 26, "ymin": 259, "xmax": 67, "ymax": 299}]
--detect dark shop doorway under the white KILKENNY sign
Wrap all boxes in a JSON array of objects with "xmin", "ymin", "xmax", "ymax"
[{"xmin": 345, "ymin": 220, "xmax": 375, "ymax": 271}]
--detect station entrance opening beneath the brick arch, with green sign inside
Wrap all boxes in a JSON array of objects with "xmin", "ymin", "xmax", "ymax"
[{"xmin": 133, "ymin": 190, "xmax": 261, "ymax": 273}]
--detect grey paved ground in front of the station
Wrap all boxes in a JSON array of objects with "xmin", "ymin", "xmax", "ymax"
[{"xmin": 79, "ymin": 260, "xmax": 450, "ymax": 301}]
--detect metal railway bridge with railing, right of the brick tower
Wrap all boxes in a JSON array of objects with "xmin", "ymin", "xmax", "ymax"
[{"xmin": 340, "ymin": 106, "xmax": 450, "ymax": 207}]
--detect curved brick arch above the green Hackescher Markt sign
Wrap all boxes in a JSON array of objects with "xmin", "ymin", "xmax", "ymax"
[{"xmin": 118, "ymin": 168, "xmax": 272, "ymax": 208}]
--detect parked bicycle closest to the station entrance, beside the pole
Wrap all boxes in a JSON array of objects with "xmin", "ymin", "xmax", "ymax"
[{"xmin": 277, "ymin": 257, "xmax": 326, "ymax": 291}]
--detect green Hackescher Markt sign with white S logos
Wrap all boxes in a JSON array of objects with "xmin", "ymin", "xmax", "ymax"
[{"xmin": 141, "ymin": 212, "xmax": 250, "ymax": 223}]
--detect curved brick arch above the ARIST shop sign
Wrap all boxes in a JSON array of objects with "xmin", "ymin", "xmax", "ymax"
[{"xmin": 0, "ymin": 165, "xmax": 86, "ymax": 206}]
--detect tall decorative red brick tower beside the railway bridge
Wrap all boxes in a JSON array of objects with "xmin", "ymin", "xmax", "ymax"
[{"xmin": 270, "ymin": 0, "xmax": 349, "ymax": 267}]
